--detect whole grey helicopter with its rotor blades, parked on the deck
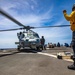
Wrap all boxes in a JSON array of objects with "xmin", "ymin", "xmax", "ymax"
[{"xmin": 0, "ymin": 8, "xmax": 70, "ymax": 51}]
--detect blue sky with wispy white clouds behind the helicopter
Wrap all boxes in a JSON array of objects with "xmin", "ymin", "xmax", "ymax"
[{"xmin": 0, "ymin": 0, "xmax": 75, "ymax": 48}]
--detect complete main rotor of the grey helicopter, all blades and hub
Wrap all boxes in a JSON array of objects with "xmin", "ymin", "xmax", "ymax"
[{"xmin": 0, "ymin": 8, "xmax": 70, "ymax": 32}]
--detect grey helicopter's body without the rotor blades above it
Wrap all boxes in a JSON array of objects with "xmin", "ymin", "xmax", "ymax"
[{"xmin": 15, "ymin": 30, "xmax": 41, "ymax": 50}]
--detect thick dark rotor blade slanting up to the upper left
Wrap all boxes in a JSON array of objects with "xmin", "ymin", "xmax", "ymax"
[{"xmin": 0, "ymin": 8, "xmax": 26, "ymax": 28}]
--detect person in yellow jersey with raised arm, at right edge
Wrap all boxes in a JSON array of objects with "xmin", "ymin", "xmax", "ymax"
[{"xmin": 63, "ymin": 4, "xmax": 75, "ymax": 70}]
